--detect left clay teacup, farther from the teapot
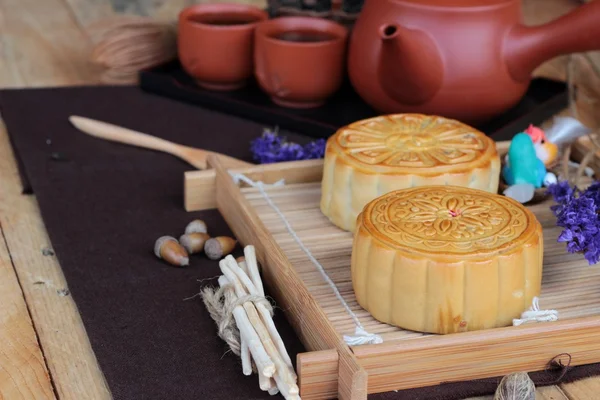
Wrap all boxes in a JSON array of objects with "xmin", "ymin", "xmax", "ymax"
[{"xmin": 177, "ymin": 3, "xmax": 268, "ymax": 90}]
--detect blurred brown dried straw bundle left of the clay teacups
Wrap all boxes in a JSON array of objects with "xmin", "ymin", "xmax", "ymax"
[{"xmin": 90, "ymin": 16, "xmax": 177, "ymax": 84}]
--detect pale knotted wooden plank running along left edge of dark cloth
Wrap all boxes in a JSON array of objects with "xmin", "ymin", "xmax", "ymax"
[{"xmin": 0, "ymin": 123, "xmax": 110, "ymax": 400}]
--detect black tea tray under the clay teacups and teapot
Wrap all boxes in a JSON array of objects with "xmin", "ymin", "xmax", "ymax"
[{"xmin": 140, "ymin": 62, "xmax": 568, "ymax": 140}]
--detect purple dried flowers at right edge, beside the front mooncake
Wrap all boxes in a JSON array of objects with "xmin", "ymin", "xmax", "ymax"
[{"xmin": 548, "ymin": 182, "xmax": 600, "ymax": 265}]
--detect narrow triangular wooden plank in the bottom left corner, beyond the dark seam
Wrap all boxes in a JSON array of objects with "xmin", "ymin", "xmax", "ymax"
[{"xmin": 0, "ymin": 225, "xmax": 55, "ymax": 400}]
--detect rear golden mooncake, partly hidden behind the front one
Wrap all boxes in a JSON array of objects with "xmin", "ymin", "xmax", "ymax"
[{"xmin": 321, "ymin": 114, "xmax": 500, "ymax": 231}]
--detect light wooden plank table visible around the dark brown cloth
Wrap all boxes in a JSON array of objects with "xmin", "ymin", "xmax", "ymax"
[{"xmin": 0, "ymin": 0, "xmax": 600, "ymax": 400}]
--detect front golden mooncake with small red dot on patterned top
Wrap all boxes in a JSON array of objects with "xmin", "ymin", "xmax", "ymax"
[{"xmin": 351, "ymin": 186, "xmax": 544, "ymax": 334}]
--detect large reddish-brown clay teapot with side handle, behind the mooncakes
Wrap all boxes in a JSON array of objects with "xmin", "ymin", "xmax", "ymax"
[{"xmin": 348, "ymin": 0, "xmax": 600, "ymax": 123}]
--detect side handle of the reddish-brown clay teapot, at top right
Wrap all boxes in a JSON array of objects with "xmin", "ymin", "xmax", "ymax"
[{"xmin": 504, "ymin": 1, "xmax": 600, "ymax": 82}]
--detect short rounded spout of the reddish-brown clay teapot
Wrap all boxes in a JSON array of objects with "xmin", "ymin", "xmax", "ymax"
[{"xmin": 377, "ymin": 24, "xmax": 444, "ymax": 105}]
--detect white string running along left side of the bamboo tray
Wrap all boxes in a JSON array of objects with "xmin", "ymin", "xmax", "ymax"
[{"xmin": 230, "ymin": 173, "xmax": 383, "ymax": 346}]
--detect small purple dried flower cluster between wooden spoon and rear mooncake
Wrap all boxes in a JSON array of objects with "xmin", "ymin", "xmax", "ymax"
[{"xmin": 250, "ymin": 129, "xmax": 326, "ymax": 164}]
